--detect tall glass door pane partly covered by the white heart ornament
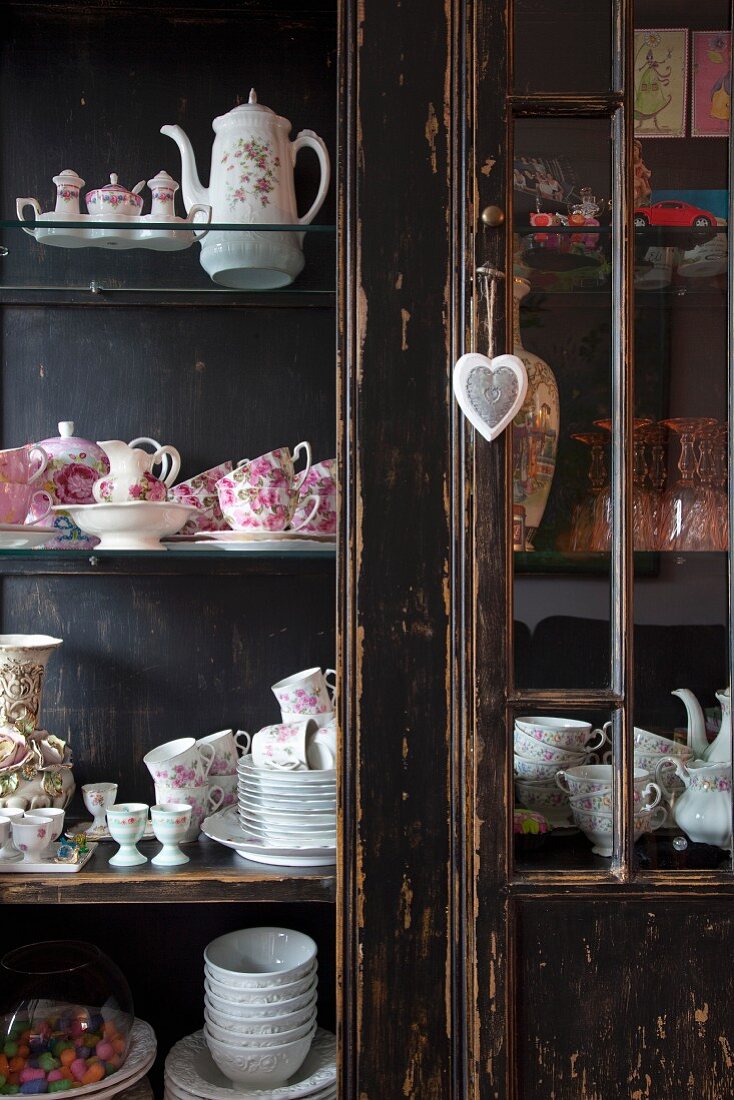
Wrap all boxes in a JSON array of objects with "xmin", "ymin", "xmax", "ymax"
[{"xmin": 513, "ymin": 119, "xmax": 612, "ymax": 688}]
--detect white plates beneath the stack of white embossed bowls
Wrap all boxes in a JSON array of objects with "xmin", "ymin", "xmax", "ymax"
[{"xmin": 165, "ymin": 1027, "xmax": 337, "ymax": 1100}]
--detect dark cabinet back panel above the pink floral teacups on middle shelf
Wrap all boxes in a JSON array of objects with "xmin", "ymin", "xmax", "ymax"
[{"xmin": 2, "ymin": 307, "xmax": 336, "ymax": 479}]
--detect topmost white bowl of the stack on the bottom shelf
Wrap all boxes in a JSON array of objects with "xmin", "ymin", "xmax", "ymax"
[{"xmin": 204, "ymin": 925, "xmax": 317, "ymax": 989}]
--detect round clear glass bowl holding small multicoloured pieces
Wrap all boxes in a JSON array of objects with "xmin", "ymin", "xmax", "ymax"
[{"xmin": 0, "ymin": 939, "xmax": 134, "ymax": 1092}]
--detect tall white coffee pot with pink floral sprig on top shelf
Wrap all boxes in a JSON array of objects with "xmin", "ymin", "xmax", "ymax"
[{"xmin": 161, "ymin": 89, "xmax": 331, "ymax": 289}]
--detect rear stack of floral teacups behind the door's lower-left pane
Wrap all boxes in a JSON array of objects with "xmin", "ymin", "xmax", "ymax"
[{"xmin": 514, "ymin": 717, "xmax": 607, "ymax": 828}]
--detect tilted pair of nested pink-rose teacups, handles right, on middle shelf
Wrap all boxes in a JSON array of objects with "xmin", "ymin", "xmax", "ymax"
[{"xmin": 217, "ymin": 442, "xmax": 318, "ymax": 531}]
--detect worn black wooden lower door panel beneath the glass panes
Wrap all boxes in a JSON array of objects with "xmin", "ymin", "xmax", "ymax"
[{"xmin": 516, "ymin": 897, "xmax": 734, "ymax": 1100}]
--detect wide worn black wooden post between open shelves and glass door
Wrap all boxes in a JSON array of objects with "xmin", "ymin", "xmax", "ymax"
[{"xmin": 346, "ymin": 0, "xmax": 454, "ymax": 1100}]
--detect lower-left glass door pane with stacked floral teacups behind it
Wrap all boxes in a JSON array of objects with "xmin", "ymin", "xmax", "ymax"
[{"xmin": 513, "ymin": 711, "xmax": 616, "ymax": 871}]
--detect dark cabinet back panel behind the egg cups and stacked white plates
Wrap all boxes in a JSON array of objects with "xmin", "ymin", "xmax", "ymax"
[{"xmin": 2, "ymin": 576, "xmax": 335, "ymax": 802}]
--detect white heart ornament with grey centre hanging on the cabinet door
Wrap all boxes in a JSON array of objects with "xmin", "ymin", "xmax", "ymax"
[{"xmin": 453, "ymin": 351, "xmax": 527, "ymax": 440}]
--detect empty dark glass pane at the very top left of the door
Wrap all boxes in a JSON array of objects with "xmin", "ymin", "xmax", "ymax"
[{"xmin": 514, "ymin": 0, "xmax": 612, "ymax": 96}]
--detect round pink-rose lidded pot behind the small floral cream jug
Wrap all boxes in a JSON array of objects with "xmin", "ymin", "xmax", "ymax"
[{"xmin": 34, "ymin": 420, "xmax": 110, "ymax": 550}]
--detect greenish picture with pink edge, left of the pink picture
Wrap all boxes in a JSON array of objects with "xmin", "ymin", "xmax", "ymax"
[{"xmin": 634, "ymin": 28, "xmax": 688, "ymax": 138}]
